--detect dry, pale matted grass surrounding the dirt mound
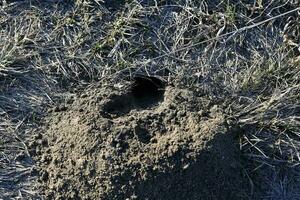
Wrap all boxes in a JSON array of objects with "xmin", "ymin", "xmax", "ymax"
[{"xmin": 0, "ymin": 0, "xmax": 300, "ymax": 199}]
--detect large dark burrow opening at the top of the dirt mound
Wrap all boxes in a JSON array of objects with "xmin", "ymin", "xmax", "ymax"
[{"xmin": 103, "ymin": 76, "xmax": 165, "ymax": 117}]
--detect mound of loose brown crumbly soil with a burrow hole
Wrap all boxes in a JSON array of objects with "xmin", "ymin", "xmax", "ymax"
[{"xmin": 32, "ymin": 78, "xmax": 245, "ymax": 199}]
